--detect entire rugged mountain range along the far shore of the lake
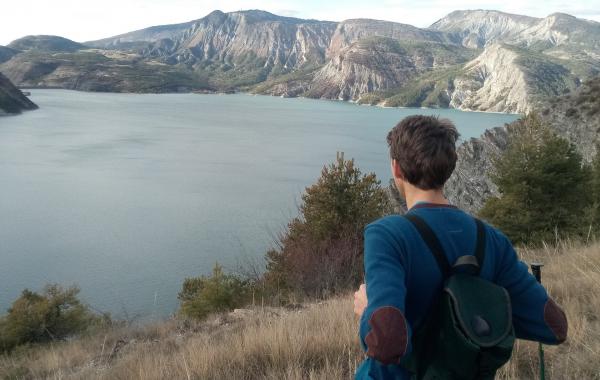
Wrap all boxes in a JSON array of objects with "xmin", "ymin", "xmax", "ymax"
[{"xmin": 0, "ymin": 10, "xmax": 600, "ymax": 113}]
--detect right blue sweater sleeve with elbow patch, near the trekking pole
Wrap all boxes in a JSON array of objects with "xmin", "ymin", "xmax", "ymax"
[{"xmin": 496, "ymin": 235, "xmax": 568, "ymax": 344}]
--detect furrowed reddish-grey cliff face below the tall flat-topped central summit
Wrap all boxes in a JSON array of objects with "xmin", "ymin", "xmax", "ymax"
[{"xmin": 173, "ymin": 11, "xmax": 336, "ymax": 69}]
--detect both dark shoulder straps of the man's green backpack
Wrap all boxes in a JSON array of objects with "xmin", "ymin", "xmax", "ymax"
[{"xmin": 404, "ymin": 213, "xmax": 485, "ymax": 278}]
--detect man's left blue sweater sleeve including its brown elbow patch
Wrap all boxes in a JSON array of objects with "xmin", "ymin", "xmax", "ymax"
[{"xmin": 360, "ymin": 223, "xmax": 411, "ymax": 364}]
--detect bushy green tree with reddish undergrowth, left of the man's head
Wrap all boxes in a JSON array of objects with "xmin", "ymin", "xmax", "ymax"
[{"xmin": 265, "ymin": 153, "xmax": 390, "ymax": 296}]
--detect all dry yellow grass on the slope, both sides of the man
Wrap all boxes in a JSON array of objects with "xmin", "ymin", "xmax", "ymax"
[{"xmin": 0, "ymin": 243, "xmax": 600, "ymax": 379}]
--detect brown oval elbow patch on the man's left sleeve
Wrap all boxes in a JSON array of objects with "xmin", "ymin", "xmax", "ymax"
[{"xmin": 365, "ymin": 306, "xmax": 408, "ymax": 364}]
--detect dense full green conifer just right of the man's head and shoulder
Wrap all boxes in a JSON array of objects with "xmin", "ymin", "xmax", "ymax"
[{"xmin": 480, "ymin": 114, "xmax": 589, "ymax": 244}]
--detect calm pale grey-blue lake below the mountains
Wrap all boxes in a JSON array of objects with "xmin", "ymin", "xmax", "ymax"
[{"xmin": 0, "ymin": 90, "xmax": 517, "ymax": 319}]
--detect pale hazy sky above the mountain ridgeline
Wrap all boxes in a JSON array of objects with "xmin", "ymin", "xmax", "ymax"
[{"xmin": 0, "ymin": 0, "xmax": 600, "ymax": 45}]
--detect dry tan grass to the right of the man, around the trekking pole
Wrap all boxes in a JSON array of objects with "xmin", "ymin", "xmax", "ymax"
[{"xmin": 498, "ymin": 242, "xmax": 600, "ymax": 379}]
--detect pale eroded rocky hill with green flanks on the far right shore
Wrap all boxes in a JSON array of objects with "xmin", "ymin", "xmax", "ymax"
[{"xmin": 354, "ymin": 44, "xmax": 580, "ymax": 113}]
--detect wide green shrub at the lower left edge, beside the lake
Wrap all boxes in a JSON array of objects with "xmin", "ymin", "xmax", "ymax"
[{"xmin": 0, "ymin": 284, "xmax": 109, "ymax": 352}]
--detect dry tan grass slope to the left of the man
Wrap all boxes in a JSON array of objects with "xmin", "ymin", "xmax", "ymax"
[{"xmin": 0, "ymin": 297, "xmax": 360, "ymax": 379}]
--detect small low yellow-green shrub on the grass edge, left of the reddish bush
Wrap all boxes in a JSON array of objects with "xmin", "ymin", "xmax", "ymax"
[{"xmin": 177, "ymin": 264, "xmax": 250, "ymax": 319}]
